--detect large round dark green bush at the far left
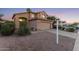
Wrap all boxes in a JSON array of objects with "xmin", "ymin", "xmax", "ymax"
[{"xmin": 0, "ymin": 21, "xmax": 15, "ymax": 36}]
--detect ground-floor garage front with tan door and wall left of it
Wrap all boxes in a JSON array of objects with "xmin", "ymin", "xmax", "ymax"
[{"xmin": 30, "ymin": 20, "xmax": 51, "ymax": 30}]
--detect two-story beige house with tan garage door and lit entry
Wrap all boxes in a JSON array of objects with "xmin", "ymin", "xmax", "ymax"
[{"xmin": 12, "ymin": 11, "xmax": 52, "ymax": 30}]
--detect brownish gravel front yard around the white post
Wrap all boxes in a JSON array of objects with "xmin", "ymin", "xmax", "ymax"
[{"xmin": 0, "ymin": 32, "xmax": 75, "ymax": 51}]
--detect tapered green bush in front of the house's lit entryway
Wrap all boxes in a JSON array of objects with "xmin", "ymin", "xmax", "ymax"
[{"xmin": 17, "ymin": 22, "xmax": 31, "ymax": 36}]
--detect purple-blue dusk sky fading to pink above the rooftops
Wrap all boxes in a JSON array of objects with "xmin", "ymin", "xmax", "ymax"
[{"xmin": 0, "ymin": 8, "xmax": 79, "ymax": 23}]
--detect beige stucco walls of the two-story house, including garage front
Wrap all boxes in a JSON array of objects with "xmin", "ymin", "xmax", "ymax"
[{"xmin": 14, "ymin": 13, "xmax": 50, "ymax": 30}]
